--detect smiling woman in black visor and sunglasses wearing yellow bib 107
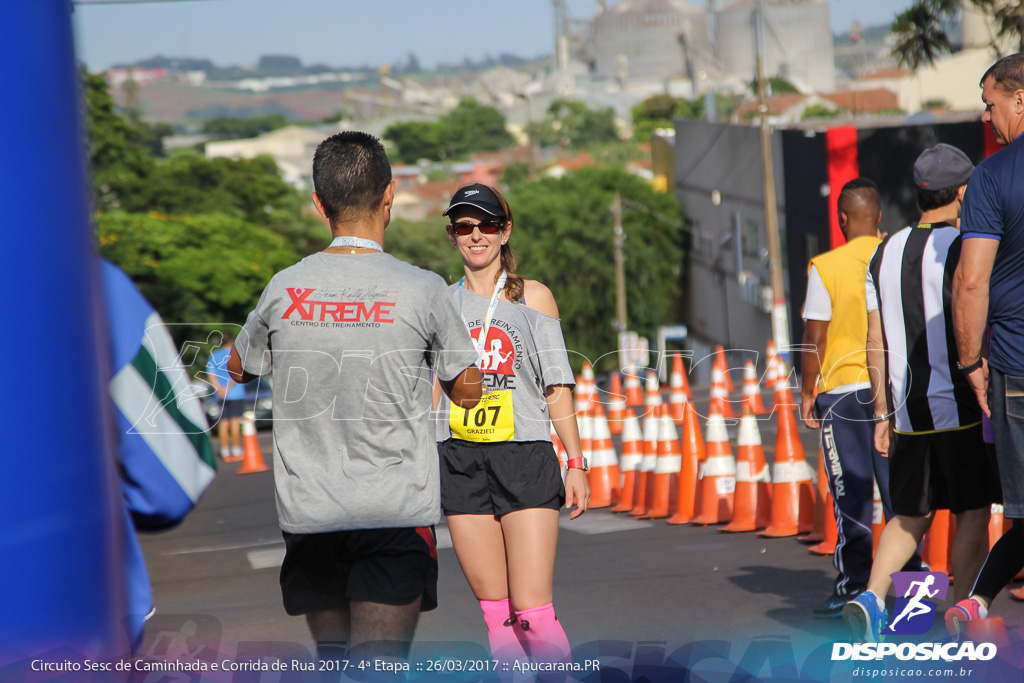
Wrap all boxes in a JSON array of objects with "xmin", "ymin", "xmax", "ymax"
[{"xmin": 435, "ymin": 184, "xmax": 590, "ymax": 661}]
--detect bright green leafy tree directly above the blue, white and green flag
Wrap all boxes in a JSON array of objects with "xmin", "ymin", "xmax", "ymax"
[{"xmin": 97, "ymin": 211, "xmax": 298, "ymax": 342}]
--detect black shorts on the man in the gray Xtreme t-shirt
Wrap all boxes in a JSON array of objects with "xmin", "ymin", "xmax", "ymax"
[{"xmin": 281, "ymin": 526, "xmax": 437, "ymax": 616}]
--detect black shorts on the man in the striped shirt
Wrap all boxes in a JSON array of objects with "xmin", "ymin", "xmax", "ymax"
[{"xmin": 889, "ymin": 424, "xmax": 1002, "ymax": 517}]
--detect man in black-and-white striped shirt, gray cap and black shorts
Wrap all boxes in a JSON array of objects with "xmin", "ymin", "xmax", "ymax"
[{"xmin": 843, "ymin": 144, "xmax": 998, "ymax": 642}]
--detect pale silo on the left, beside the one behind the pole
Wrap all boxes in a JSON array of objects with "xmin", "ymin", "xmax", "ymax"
[{"xmin": 593, "ymin": 0, "xmax": 711, "ymax": 81}]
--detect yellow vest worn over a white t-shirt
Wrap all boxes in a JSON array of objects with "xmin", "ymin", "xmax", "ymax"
[{"xmin": 807, "ymin": 236, "xmax": 882, "ymax": 392}]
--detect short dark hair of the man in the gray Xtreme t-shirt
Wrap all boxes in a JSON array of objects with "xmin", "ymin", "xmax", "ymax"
[{"xmin": 313, "ymin": 131, "xmax": 391, "ymax": 223}]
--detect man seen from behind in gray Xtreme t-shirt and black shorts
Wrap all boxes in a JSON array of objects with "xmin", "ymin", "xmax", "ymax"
[{"xmin": 228, "ymin": 132, "xmax": 482, "ymax": 658}]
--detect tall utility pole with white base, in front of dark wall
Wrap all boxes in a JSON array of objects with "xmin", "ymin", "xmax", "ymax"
[{"xmin": 758, "ymin": 54, "xmax": 790, "ymax": 360}]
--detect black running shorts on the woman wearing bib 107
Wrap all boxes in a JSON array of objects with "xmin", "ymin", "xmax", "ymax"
[{"xmin": 437, "ymin": 438, "xmax": 565, "ymax": 515}]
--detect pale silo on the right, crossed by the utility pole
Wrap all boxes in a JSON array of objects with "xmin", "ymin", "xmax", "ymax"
[{"xmin": 715, "ymin": 0, "xmax": 836, "ymax": 92}]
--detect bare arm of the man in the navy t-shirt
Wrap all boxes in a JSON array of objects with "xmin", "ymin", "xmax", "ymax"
[{"xmin": 953, "ymin": 238, "xmax": 999, "ymax": 417}]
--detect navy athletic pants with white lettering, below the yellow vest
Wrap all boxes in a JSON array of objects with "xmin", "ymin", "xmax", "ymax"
[{"xmin": 814, "ymin": 389, "xmax": 922, "ymax": 595}]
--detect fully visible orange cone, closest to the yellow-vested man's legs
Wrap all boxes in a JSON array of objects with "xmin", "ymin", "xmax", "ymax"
[{"xmin": 761, "ymin": 401, "xmax": 814, "ymax": 539}]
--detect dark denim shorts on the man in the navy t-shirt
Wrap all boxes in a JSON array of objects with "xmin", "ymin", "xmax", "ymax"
[{"xmin": 988, "ymin": 368, "xmax": 1024, "ymax": 519}]
